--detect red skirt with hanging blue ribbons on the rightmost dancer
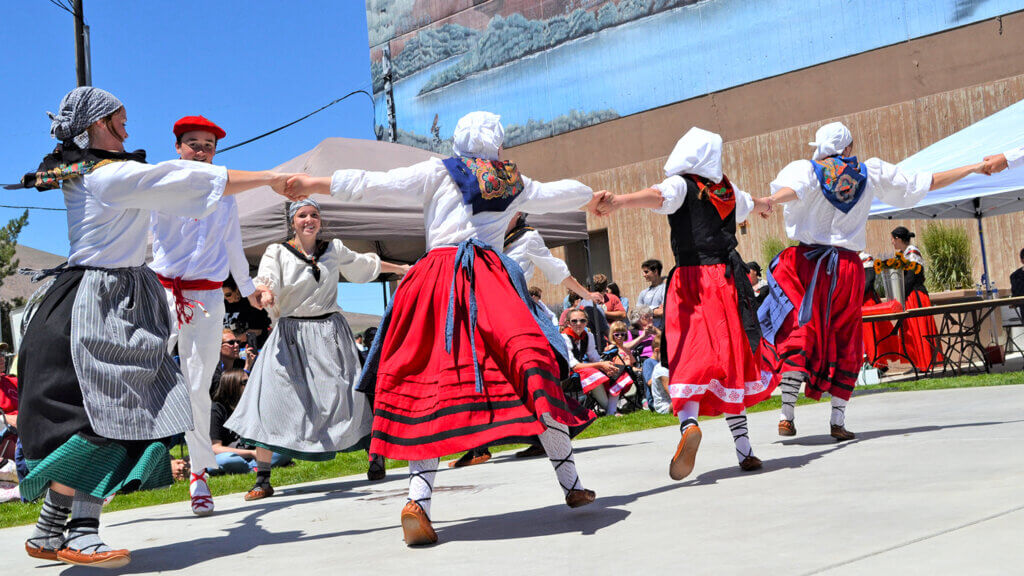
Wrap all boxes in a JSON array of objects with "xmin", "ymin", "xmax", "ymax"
[{"xmin": 761, "ymin": 245, "xmax": 864, "ymax": 400}]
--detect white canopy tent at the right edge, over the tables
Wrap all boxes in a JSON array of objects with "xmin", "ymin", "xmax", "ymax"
[{"xmin": 869, "ymin": 100, "xmax": 1024, "ymax": 286}]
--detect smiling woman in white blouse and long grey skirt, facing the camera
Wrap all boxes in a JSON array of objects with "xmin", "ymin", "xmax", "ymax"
[{"xmin": 224, "ymin": 199, "xmax": 404, "ymax": 500}]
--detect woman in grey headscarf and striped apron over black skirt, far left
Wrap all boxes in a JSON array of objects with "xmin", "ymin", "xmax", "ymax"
[{"xmin": 18, "ymin": 86, "xmax": 289, "ymax": 568}]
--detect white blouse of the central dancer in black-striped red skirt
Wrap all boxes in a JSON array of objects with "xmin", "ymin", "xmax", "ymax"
[{"xmin": 331, "ymin": 158, "xmax": 593, "ymax": 250}]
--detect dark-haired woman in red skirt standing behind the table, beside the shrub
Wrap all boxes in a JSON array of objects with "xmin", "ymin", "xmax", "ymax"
[{"xmin": 892, "ymin": 227, "xmax": 942, "ymax": 371}]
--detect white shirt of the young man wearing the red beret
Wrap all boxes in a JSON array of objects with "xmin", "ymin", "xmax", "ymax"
[{"xmin": 150, "ymin": 196, "xmax": 256, "ymax": 298}]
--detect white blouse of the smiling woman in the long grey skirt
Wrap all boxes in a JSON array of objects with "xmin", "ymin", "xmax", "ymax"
[{"xmin": 256, "ymin": 239, "xmax": 381, "ymax": 322}]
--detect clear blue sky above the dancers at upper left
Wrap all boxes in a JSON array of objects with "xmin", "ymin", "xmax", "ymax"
[{"xmin": 0, "ymin": 0, "xmax": 383, "ymax": 314}]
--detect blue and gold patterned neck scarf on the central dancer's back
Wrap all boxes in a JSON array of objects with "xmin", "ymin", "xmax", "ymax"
[{"xmin": 443, "ymin": 156, "xmax": 524, "ymax": 214}]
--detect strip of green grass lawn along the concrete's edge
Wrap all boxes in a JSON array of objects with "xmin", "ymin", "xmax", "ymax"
[{"xmin": 0, "ymin": 372, "xmax": 1024, "ymax": 528}]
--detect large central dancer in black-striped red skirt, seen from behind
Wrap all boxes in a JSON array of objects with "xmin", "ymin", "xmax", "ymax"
[{"xmin": 289, "ymin": 112, "xmax": 608, "ymax": 546}]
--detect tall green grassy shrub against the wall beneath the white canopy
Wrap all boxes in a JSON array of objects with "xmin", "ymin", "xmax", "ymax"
[{"xmin": 921, "ymin": 222, "xmax": 974, "ymax": 292}]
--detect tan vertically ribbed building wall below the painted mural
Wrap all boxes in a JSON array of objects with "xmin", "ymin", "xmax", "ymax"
[{"xmin": 524, "ymin": 75, "xmax": 1024, "ymax": 311}]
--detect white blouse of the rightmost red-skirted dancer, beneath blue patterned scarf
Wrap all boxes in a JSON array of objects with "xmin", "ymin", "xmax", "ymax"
[{"xmin": 771, "ymin": 158, "xmax": 932, "ymax": 252}]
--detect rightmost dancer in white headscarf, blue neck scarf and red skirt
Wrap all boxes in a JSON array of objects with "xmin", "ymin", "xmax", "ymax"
[{"xmin": 758, "ymin": 122, "xmax": 983, "ymax": 441}]
